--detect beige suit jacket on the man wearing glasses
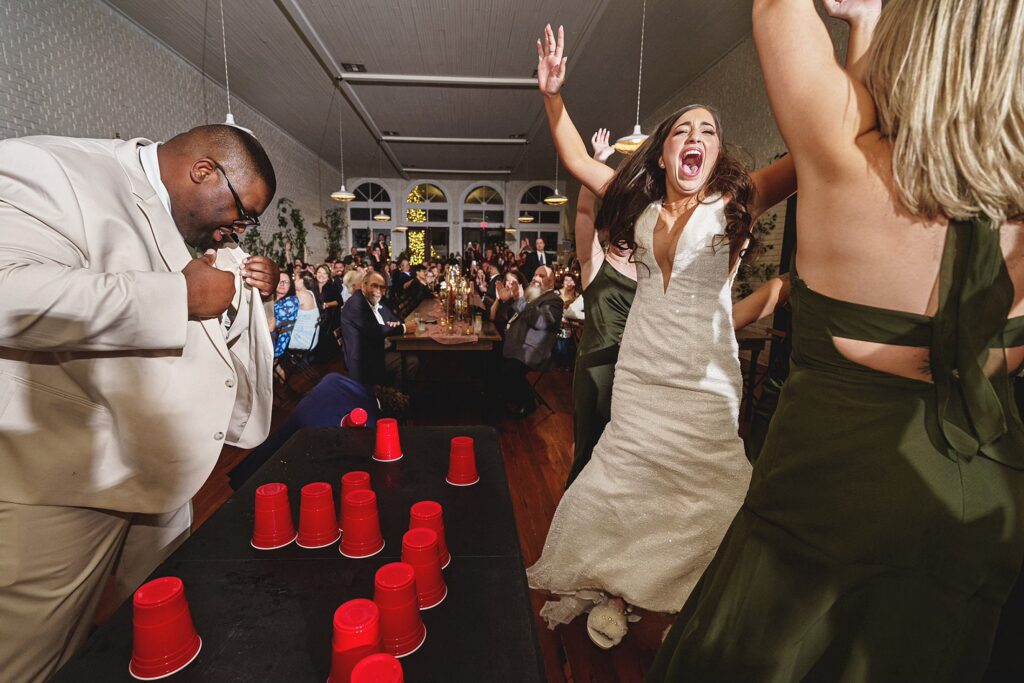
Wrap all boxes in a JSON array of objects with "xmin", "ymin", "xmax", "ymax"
[{"xmin": 0, "ymin": 136, "xmax": 273, "ymax": 513}]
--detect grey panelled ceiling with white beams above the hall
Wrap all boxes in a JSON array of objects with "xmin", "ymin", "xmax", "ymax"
[{"xmin": 106, "ymin": 0, "xmax": 751, "ymax": 178}]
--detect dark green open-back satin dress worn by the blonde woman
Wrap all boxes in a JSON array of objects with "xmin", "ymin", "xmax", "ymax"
[{"xmin": 647, "ymin": 220, "xmax": 1024, "ymax": 683}]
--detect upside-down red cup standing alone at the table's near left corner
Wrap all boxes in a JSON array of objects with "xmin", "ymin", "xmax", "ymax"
[{"xmin": 128, "ymin": 577, "xmax": 203, "ymax": 681}]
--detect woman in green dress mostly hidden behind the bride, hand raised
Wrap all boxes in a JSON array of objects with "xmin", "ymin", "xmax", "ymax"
[{"xmin": 565, "ymin": 128, "xmax": 637, "ymax": 488}]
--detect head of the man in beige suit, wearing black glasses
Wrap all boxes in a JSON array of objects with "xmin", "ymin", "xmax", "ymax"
[{"xmin": 157, "ymin": 125, "xmax": 278, "ymax": 249}]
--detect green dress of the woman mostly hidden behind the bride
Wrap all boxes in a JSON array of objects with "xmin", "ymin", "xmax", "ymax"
[{"xmin": 565, "ymin": 260, "xmax": 637, "ymax": 488}]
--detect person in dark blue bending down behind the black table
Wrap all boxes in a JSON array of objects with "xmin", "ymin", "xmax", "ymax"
[{"xmin": 227, "ymin": 373, "xmax": 409, "ymax": 490}]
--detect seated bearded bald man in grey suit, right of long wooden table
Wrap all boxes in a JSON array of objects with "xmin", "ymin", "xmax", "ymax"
[{"xmin": 503, "ymin": 266, "xmax": 562, "ymax": 417}]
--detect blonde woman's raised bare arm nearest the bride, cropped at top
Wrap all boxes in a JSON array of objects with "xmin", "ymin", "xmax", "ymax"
[{"xmin": 754, "ymin": 0, "xmax": 877, "ymax": 174}]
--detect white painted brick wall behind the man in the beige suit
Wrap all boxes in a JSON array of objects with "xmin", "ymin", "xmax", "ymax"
[{"xmin": 0, "ymin": 0, "xmax": 341, "ymax": 258}]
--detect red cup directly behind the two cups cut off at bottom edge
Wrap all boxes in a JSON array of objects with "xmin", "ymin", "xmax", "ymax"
[{"xmin": 372, "ymin": 565, "xmax": 427, "ymax": 657}]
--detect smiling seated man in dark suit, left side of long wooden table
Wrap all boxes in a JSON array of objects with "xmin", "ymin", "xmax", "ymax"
[{"xmin": 341, "ymin": 270, "xmax": 406, "ymax": 386}]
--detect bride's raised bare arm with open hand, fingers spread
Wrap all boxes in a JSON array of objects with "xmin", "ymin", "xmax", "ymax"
[{"xmin": 537, "ymin": 24, "xmax": 614, "ymax": 197}]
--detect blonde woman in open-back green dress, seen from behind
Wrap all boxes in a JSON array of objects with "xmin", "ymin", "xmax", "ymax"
[{"xmin": 648, "ymin": 0, "xmax": 1024, "ymax": 683}]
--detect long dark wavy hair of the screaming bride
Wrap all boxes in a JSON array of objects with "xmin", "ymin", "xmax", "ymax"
[{"xmin": 595, "ymin": 104, "xmax": 754, "ymax": 258}]
